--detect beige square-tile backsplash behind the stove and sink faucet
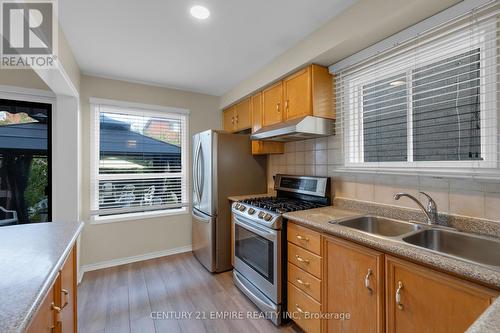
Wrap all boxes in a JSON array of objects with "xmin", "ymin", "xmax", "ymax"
[{"xmin": 268, "ymin": 136, "xmax": 500, "ymax": 222}]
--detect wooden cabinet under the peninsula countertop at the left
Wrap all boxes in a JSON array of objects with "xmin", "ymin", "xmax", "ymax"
[{"xmin": 27, "ymin": 246, "xmax": 78, "ymax": 333}]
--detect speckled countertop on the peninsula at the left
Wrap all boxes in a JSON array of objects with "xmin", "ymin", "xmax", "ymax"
[{"xmin": 0, "ymin": 222, "xmax": 83, "ymax": 333}]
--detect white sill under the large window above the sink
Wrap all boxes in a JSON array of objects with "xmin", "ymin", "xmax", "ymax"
[{"xmin": 332, "ymin": 167, "xmax": 500, "ymax": 182}]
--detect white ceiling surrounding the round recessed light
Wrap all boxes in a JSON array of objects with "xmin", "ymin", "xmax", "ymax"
[{"xmin": 59, "ymin": 0, "xmax": 356, "ymax": 96}]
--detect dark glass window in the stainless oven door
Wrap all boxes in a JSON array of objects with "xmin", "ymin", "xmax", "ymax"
[{"xmin": 234, "ymin": 224, "xmax": 274, "ymax": 283}]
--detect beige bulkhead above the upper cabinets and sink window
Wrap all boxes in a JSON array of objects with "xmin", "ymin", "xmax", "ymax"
[{"xmin": 220, "ymin": 0, "xmax": 460, "ymax": 108}]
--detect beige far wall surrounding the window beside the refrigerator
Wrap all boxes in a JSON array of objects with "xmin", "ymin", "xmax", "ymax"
[{"xmin": 80, "ymin": 76, "xmax": 220, "ymax": 265}]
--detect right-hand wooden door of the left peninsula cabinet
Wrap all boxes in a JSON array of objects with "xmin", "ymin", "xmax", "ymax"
[{"xmin": 60, "ymin": 247, "xmax": 77, "ymax": 333}]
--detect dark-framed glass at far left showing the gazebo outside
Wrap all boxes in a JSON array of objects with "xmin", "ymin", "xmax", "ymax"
[{"xmin": 0, "ymin": 99, "xmax": 52, "ymax": 226}]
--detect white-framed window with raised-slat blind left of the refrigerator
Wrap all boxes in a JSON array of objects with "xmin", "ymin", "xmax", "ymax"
[{"xmin": 91, "ymin": 99, "xmax": 188, "ymax": 221}]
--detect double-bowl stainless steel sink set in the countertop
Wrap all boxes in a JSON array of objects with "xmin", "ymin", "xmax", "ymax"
[{"xmin": 331, "ymin": 215, "xmax": 500, "ymax": 270}]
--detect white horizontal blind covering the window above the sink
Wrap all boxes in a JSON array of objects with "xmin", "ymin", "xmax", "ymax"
[{"xmin": 335, "ymin": 2, "xmax": 500, "ymax": 178}]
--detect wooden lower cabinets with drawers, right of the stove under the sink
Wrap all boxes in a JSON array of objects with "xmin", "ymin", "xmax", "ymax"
[{"xmin": 287, "ymin": 221, "xmax": 500, "ymax": 333}]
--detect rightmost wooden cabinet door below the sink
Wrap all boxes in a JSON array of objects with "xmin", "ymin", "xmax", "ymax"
[{"xmin": 386, "ymin": 257, "xmax": 497, "ymax": 333}]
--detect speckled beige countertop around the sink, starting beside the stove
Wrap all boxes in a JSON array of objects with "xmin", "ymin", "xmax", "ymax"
[{"xmin": 283, "ymin": 206, "xmax": 500, "ymax": 333}]
